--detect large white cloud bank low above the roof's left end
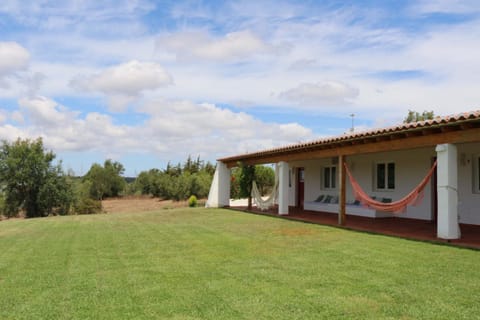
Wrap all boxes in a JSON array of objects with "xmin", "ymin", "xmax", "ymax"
[{"xmin": 142, "ymin": 100, "xmax": 313, "ymax": 156}]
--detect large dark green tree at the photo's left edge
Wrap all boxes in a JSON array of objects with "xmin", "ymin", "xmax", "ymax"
[{"xmin": 0, "ymin": 138, "xmax": 73, "ymax": 218}]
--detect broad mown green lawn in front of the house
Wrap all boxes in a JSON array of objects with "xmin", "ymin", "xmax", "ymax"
[{"xmin": 0, "ymin": 208, "xmax": 480, "ymax": 319}]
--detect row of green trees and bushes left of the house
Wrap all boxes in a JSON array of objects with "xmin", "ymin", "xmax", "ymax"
[{"xmin": 0, "ymin": 138, "xmax": 215, "ymax": 218}]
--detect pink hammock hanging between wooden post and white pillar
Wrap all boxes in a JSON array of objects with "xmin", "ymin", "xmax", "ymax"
[{"xmin": 344, "ymin": 161, "xmax": 437, "ymax": 213}]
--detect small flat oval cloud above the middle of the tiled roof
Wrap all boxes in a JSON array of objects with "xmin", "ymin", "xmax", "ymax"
[{"xmin": 279, "ymin": 81, "xmax": 358, "ymax": 106}]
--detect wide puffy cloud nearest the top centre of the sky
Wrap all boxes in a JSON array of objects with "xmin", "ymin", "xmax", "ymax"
[{"xmin": 156, "ymin": 30, "xmax": 275, "ymax": 61}]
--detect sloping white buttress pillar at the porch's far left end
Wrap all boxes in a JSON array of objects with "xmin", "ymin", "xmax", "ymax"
[{"xmin": 205, "ymin": 162, "xmax": 230, "ymax": 208}]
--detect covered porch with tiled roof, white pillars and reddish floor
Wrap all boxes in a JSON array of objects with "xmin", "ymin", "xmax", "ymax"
[{"xmin": 207, "ymin": 112, "xmax": 480, "ymax": 244}]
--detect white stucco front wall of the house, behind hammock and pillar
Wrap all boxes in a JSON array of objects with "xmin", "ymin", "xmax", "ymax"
[{"xmin": 289, "ymin": 143, "xmax": 480, "ymax": 225}]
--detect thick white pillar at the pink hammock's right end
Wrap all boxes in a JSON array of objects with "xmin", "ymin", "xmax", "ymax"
[{"xmin": 435, "ymin": 144, "xmax": 460, "ymax": 239}]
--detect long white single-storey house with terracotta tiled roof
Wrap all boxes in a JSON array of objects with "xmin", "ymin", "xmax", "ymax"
[{"xmin": 207, "ymin": 111, "xmax": 480, "ymax": 239}]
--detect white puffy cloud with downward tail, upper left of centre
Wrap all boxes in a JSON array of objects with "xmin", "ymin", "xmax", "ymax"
[{"xmin": 70, "ymin": 60, "xmax": 173, "ymax": 111}]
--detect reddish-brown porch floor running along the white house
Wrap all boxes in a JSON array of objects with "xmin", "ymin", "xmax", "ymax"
[{"xmin": 230, "ymin": 206, "xmax": 480, "ymax": 249}]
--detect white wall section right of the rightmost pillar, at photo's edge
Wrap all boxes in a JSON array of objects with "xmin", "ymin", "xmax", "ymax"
[{"xmin": 457, "ymin": 143, "xmax": 480, "ymax": 225}]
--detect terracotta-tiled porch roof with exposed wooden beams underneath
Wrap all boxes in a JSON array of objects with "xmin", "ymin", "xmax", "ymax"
[{"xmin": 218, "ymin": 110, "xmax": 480, "ymax": 167}]
